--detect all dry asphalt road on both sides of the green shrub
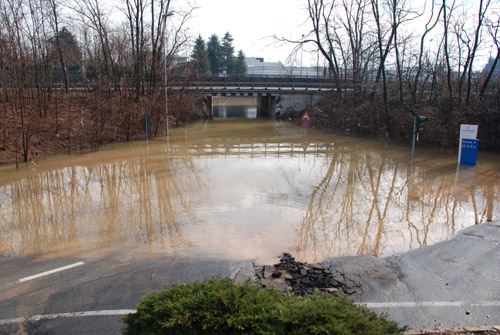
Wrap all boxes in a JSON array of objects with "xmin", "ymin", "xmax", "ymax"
[{"xmin": 0, "ymin": 222, "xmax": 500, "ymax": 335}]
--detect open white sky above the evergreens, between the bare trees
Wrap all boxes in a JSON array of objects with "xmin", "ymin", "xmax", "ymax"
[{"xmin": 189, "ymin": 0, "xmax": 316, "ymax": 65}]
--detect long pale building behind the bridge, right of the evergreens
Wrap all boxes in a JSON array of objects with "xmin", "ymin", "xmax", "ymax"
[{"xmin": 245, "ymin": 57, "xmax": 327, "ymax": 77}]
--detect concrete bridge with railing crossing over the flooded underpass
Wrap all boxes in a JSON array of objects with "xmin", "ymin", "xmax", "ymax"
[{"xmin": 191, "ymin": 75, "xmax": 335, "ymax": 116}]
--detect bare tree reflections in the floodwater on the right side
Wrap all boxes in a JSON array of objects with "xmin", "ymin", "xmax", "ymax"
[{"xmin": 288, "ymin": 145, "xmax": 500, "ymax": 260}]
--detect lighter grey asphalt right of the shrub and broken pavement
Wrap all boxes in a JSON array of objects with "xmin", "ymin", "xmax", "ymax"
[{"xmin": 323, "ymin": 222, "xmax": 500, "ymax": 329}]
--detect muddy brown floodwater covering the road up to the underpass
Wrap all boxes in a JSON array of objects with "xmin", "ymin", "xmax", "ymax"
[{"xmin": 0, "ymin": 119, "xmax": 500, "ymax": 263}]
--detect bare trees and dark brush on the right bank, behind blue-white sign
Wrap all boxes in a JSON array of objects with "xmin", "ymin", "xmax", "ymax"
[{"xmin": 290, "ymin": 0, "xmax": 500, "ymax": 149}]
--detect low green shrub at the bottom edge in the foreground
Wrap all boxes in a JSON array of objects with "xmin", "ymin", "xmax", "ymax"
[{"xmin": 124, "ymin": 278, "xmax": 405, "ymax": 335}]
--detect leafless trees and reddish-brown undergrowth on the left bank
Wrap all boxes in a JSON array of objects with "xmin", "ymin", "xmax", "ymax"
[{"xmin": 0, "ymin": 0, "xmax": 203, "ymax": 167}]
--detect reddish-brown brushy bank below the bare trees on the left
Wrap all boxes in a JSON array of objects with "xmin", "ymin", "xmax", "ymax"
[{"xmin": 0, "ymin": 90, "xmax": 200, "ymax": 164}]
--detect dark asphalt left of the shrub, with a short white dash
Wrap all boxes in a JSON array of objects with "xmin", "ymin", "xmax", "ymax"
[{"xmin": 0, "ymin": 252, "xmax": 253, "ymax": 335}]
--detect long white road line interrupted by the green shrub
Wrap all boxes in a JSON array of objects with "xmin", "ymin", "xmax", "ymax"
[{"xmin": 0, "ymin": 301, "xmax": 500, "ymax": 326}]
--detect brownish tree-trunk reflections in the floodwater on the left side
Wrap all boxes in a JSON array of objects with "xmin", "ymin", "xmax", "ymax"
[{"xmin": 0, "ymin": 146, "xmax": 204, "ymax": 255}]
